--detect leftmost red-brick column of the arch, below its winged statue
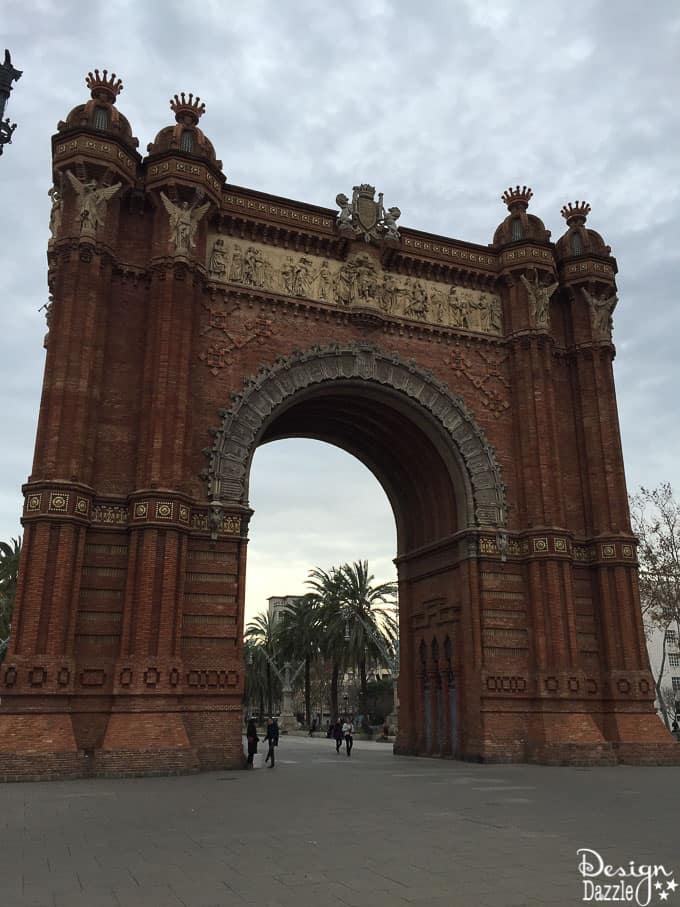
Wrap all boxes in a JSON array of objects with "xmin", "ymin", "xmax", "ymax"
[{"xmin": 0, "ymin": 238, "xmax": 117, "ymax": 777}]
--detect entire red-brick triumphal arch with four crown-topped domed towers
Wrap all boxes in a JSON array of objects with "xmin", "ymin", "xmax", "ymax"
[{"xmin": 0, "ymin": 72, "xmax": 677, "ymax": 778}]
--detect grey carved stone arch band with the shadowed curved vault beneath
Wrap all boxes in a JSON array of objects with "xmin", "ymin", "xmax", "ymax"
[{"xmin": 207, "ymin": 345, "xmax": 506, "ymax": 552}]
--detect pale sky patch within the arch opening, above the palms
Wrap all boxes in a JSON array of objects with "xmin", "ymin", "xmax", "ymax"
[{"xmin": 245, "ymin": 438, "xmax": 397, "ymax": 622}]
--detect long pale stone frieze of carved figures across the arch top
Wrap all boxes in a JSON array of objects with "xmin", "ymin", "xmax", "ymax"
[{"xmin": 206, "ymin": 234, "xmax": 503, "ymax": 336}]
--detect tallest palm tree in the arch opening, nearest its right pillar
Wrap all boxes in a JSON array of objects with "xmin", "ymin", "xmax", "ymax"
[{"xmin": 336, "ymin": 561, "xmax": 397, "ymax": 706}]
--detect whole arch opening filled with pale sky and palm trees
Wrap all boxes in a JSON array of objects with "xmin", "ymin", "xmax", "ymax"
[{"xmin": 244, "ymin": 438, "xmax": 398, "ymax": 733}]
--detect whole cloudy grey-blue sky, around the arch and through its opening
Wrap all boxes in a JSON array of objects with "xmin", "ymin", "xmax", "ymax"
[{"xmin": 0, "ymin": 0, "xmax": 680, "ymax": 613}]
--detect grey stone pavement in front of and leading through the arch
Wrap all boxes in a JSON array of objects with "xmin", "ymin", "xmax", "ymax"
[{"xmin": 0, "ymin": 737, "xmax": 680, "ymax": 907}]
